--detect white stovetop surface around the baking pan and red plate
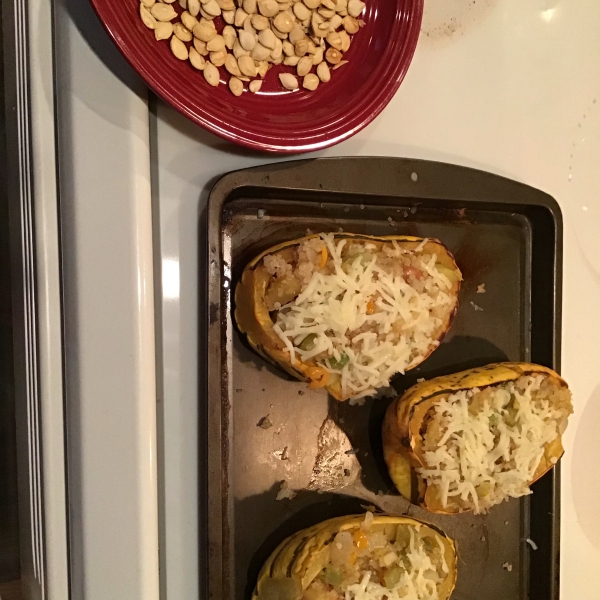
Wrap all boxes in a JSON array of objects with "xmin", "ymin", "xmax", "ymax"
[{"xmin": 57, "ymin": 0, "xmax": 600, "ymax": 600}]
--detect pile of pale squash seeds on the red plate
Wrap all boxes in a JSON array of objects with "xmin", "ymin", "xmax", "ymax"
[{"xmin": 140, "ymin": 0, "xmax": 365, "ymax": 96}]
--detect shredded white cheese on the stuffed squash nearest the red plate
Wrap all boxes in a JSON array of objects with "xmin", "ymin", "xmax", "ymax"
[{"xmin": 274, "ymin": 234, "xmax": 456, "ymax": 399}]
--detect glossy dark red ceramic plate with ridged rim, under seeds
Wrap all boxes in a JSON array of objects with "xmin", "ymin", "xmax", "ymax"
[{"xmin": 92, "ymin": 0, "xmax": 423, "ymax": 153}]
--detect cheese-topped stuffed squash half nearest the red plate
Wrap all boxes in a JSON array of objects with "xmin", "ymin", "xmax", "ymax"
[{"xmin": 235, "ymin": 233, "xmax": 462, "ymax": 400}]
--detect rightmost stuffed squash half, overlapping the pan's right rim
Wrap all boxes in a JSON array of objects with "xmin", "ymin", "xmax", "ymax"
[{"xmin": 382, "ymin": 363, "xmax": 573, "ymax": 514}]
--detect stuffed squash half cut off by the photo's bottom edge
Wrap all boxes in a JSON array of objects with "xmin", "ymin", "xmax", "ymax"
[{"xmin": 252, "ymin": 513, "xmax": 456, "ymax": 600}]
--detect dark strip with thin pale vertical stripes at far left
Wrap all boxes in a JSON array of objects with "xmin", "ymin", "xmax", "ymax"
[{"xmin": 2, "ymin": 0, "xmax": 46, "ymax": 599}]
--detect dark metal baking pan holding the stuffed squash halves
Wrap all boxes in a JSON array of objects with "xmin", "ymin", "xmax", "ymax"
[{"xmin": 206, "ymin": 158, "xmax": 562, "ymax": 600}]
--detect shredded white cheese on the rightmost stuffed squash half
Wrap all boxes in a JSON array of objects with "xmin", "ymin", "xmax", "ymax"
[{"xmin": 417, "ymin": 375, "xmax": 569, "ymax": 513}]
